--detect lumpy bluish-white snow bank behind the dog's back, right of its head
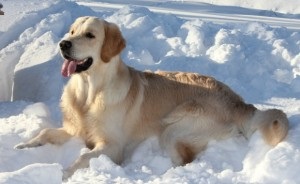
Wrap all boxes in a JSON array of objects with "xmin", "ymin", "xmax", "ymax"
[{"xmin": 107, "ymin": 7, "xmax": 300, "ymax": 102}]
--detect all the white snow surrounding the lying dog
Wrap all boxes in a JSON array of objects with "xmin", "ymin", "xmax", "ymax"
[{"xmin": 0, "ymin": 0, "xmax": 300, "ymax": 184}]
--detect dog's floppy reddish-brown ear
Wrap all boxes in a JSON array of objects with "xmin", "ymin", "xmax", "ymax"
[{"xmin": 101, "ymin": 21, "xmax": 126, "ymax": 63}]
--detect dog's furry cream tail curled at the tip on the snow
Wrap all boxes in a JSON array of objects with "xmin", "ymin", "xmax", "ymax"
[{"xmin": 242, "ymin": 109, "xmax": 289, "ymax": 146}]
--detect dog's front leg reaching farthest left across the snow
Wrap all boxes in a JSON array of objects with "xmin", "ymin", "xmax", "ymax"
[{"xmin": 15, "ymin": 128, "xmax": 71, "ymax": 149}]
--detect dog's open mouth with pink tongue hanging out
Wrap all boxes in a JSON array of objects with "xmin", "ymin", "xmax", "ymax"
[{"xmin": 61, "ymin": 57, "xmax": 93, "ymax": 77}]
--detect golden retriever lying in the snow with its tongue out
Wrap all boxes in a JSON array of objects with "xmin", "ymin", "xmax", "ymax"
[{"xmin": 16, "ymin": 17, "xmax": 289, "ymax": 178}]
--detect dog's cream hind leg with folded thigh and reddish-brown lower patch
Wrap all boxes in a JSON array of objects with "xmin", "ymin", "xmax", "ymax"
[{"xmin": 160, "ymin": 100, "xmax": 238, "ymax": 165}]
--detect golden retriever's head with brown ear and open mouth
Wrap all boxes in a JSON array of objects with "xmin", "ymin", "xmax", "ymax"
[{"xmin": 59, "ymin": 17, "xmax": 125, "ymax": 77}]
